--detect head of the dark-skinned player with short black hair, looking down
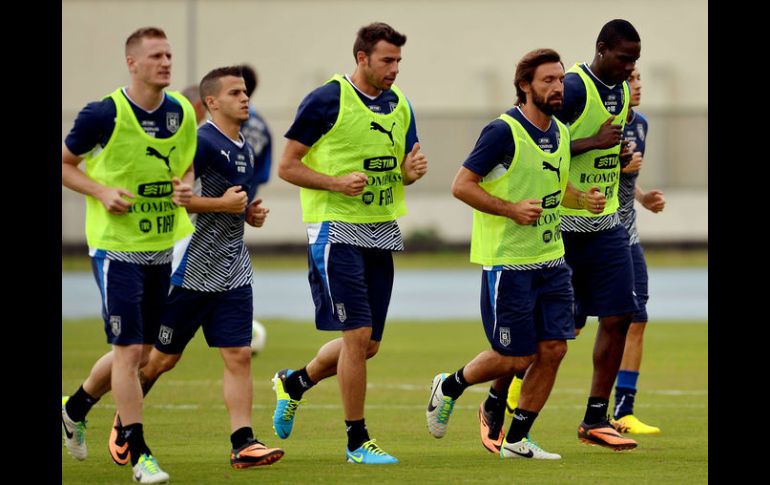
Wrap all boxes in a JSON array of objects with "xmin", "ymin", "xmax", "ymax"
[{"xmin": 594, "ymin": 19, "xmax": 642, "ymax": 84}]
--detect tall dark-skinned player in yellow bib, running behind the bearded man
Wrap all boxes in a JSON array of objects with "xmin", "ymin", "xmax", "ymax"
[{"xmin": 555, "ymin": 19, "xmax": 641, "ymax": 451}]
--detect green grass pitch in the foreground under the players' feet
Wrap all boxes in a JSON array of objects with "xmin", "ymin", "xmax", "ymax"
[{"xmin": 62, "ymin": 320, "xmax": 708, "ymax": 484}]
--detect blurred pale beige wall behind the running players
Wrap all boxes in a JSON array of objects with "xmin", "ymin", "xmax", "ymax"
[{"xmin": 62, "ymin": 0, "xmax": 708, "ymax": 250}]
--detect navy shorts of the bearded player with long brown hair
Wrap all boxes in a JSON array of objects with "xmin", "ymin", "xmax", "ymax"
[{"xmin": 481, "ymin": 264, "xmax": 575, "ymax": 356}]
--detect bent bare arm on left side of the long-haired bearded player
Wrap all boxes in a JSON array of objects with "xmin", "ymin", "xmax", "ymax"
[{"xmin": 452, "ymin": 167, "xmax": 543, "ymax": 225}]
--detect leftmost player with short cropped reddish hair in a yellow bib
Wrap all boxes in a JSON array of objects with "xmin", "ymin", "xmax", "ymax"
[{"xmin": 61, "ymin": 27, "xmax": 196, "ymax": 483}]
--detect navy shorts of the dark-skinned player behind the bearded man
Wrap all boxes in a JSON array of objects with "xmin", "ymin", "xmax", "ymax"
[{"xmin": 563, "ymin": 224, "xmax": 637, "ymax": 328}]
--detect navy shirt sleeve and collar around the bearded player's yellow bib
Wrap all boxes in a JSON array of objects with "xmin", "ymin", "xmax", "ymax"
[{"xmin": 463, "ymin": 106, "xmax": 560, "ymax": 177}]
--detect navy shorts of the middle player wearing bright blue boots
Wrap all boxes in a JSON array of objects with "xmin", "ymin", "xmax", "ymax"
[{"xmin": 307, "ymin": 243, "xmax": 393, "ymax": 342}]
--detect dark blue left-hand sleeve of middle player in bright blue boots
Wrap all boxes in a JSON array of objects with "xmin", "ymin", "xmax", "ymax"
[{"xmin": 284, "ymin": 82, "xmax": 340, "ymax": 146}]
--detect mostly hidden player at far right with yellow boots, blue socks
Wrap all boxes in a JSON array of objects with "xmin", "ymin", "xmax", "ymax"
[{"xmin": 611, "ymin": 68, "xmax": 666, "ymax": 434}]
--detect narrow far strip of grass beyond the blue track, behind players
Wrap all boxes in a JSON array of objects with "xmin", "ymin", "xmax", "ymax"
[{"xmin": 62, "ymin": 249, "xmax": 708, "ymax": 271}]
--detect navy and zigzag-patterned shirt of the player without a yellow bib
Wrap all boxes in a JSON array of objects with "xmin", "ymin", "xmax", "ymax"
[{"xmin": 171, "ymin": 120, "xmax": 257, "ymax": 292}]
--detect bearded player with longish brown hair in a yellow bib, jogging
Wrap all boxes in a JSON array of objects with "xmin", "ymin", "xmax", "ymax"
[{"xmin": 426, "ymin": 49, "xmax": 605, "ymax": 460}]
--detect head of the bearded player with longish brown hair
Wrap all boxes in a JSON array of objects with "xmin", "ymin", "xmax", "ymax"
[{"xmin": 513, "ymin": 49, "xmax": 564, "ymax": 116}]
